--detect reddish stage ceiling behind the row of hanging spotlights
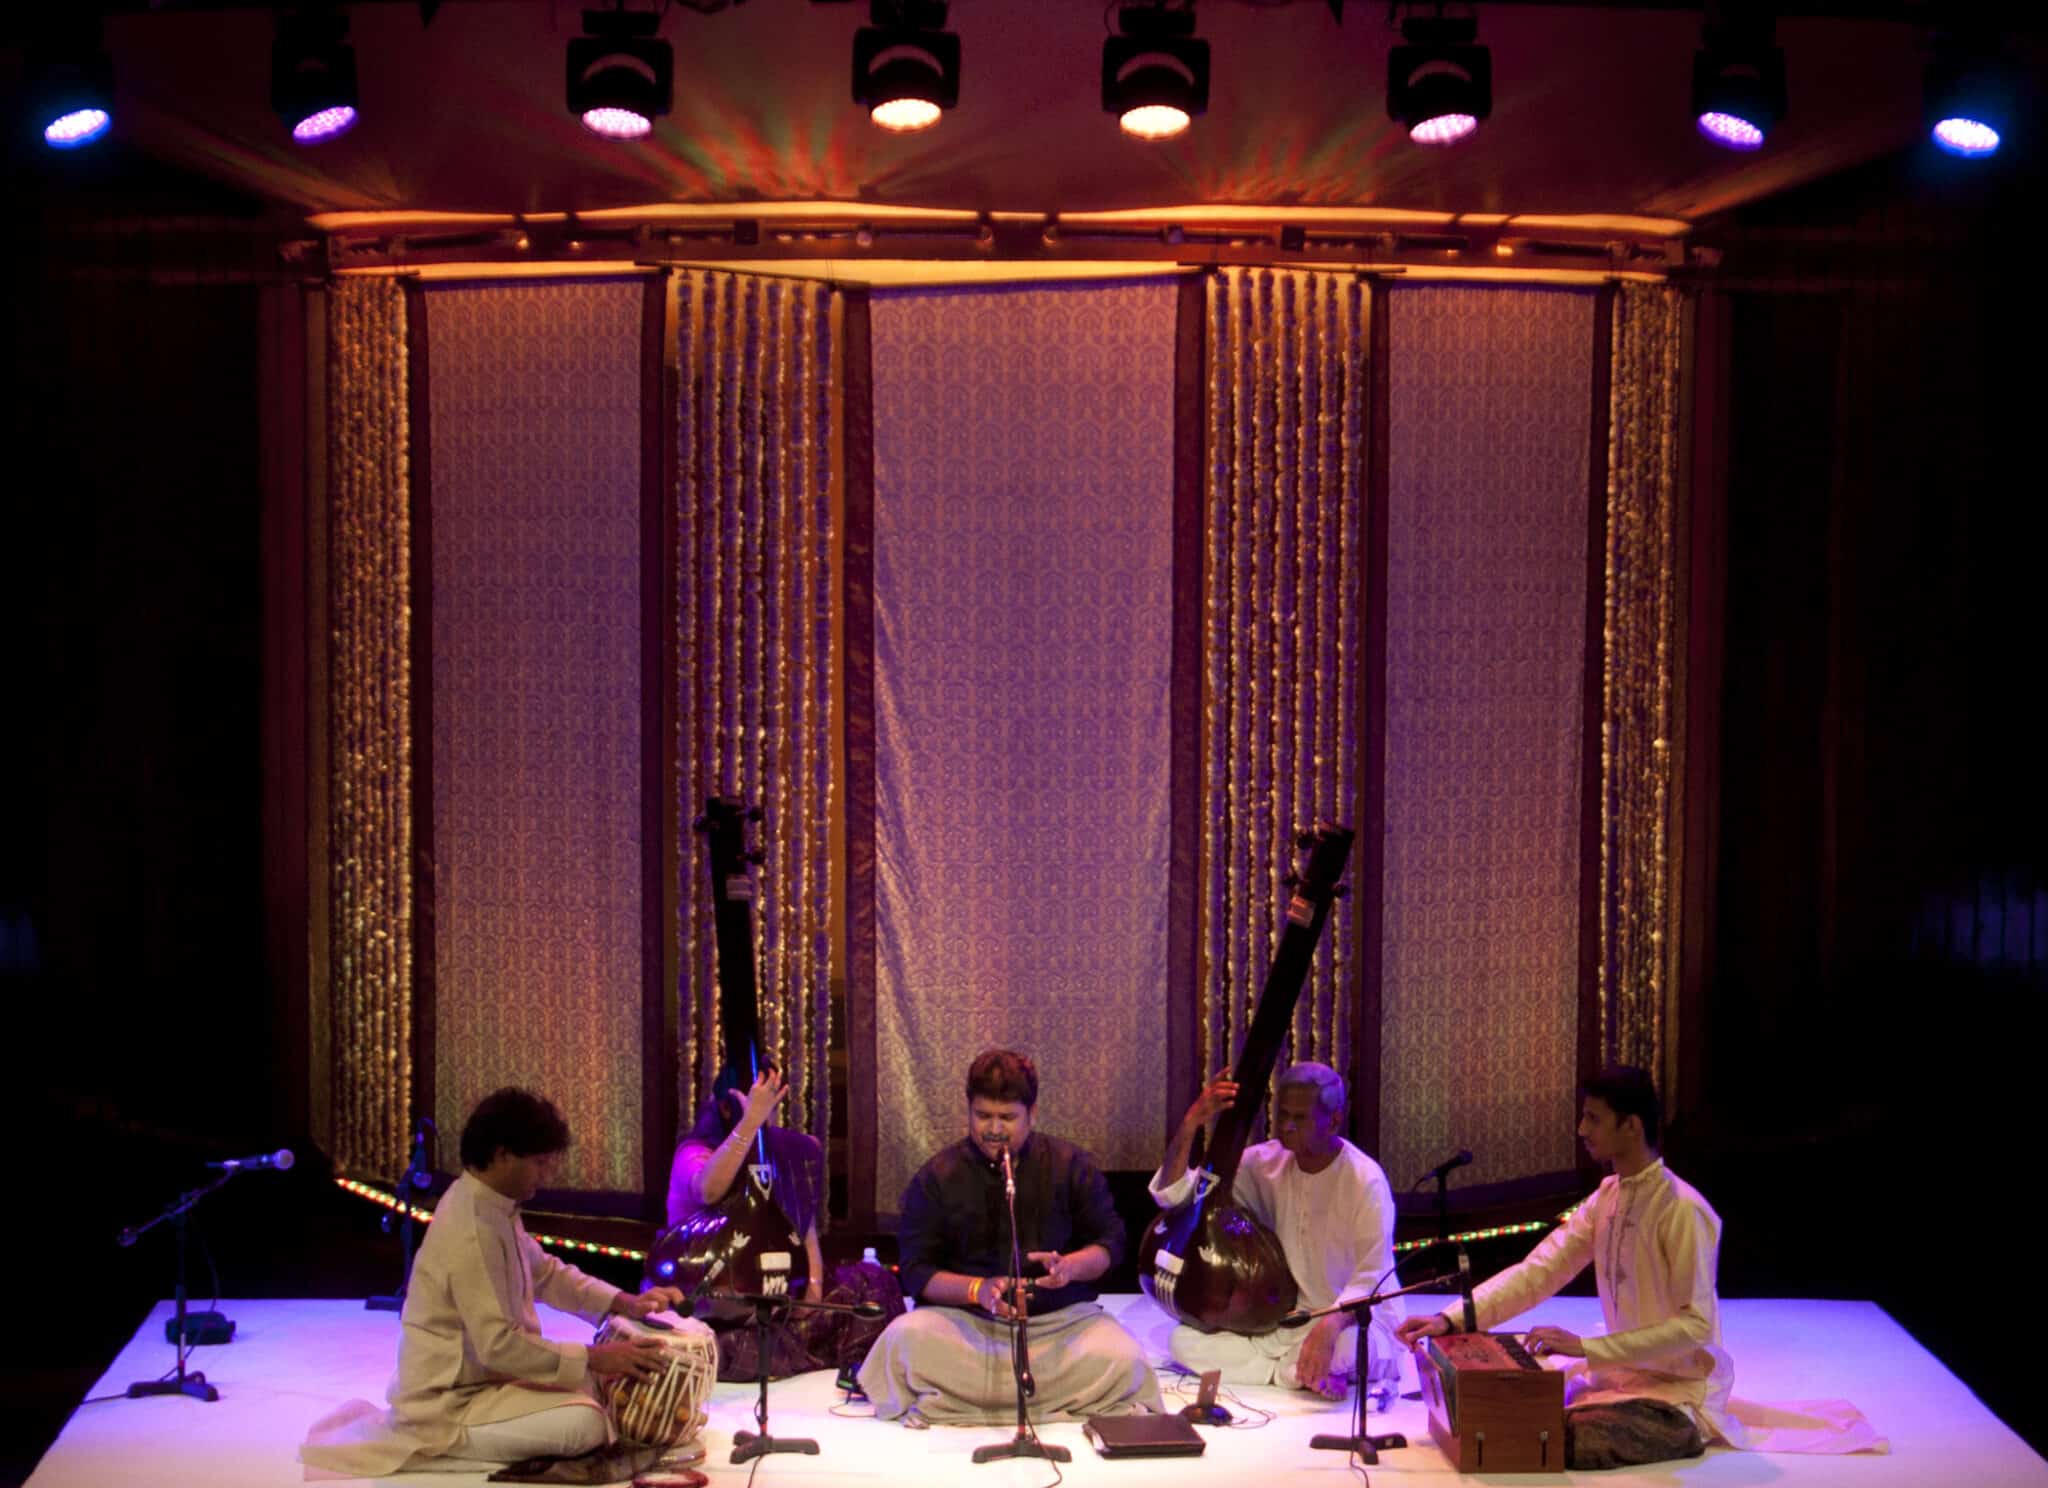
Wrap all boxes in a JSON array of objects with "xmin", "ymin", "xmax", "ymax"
[{"xmin": 28, "ymin": 0, "xmax": 1949, "ymax": 221}]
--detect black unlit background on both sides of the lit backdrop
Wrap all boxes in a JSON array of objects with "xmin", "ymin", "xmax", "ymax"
[{"xmin": 0, "ymin": 130, "xmax": 2048, "ymax": 1482}]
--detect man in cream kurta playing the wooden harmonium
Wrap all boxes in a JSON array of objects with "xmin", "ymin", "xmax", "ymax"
[{"xmin": 1401, "ymin": 1064, "xmax": 1735, "ymax": 1468}]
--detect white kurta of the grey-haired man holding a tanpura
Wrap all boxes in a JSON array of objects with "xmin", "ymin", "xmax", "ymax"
[{"xmin": 1151, "ymin": 1138, "xmax": 1405, "ymax": 1384}]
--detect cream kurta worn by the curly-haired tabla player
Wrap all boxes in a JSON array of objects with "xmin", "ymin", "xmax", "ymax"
[{"xmin": 299, "ymin": 1173, "xmax": 618, "ymax": 1478}]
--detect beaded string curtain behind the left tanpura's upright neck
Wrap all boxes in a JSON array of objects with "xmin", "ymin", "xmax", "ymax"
[{"xmin": 670, "ymin": 272, "xmax": 840, "ymax": 1140}]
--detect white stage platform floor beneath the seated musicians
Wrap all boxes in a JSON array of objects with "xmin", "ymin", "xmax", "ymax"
[{"xmin": 29, "ymin": 1296, "xmax": 2048, "ymax": 1488}]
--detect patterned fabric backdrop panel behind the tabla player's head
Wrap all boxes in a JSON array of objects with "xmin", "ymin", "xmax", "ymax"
[{"xmin": 426, "ymin": 278, "xmax": 645, "ymax": 1193}]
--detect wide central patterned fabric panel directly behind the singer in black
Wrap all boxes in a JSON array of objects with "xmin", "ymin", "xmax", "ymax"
[{"xmin": 872, "ymin": 282, "xmax": 1178, "ymax": 1210}]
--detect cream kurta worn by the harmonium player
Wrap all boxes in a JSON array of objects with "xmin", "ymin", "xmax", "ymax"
[{"xmin": 1444, "ymin": 1158, "xmax": 1743, "ymax": 1443}]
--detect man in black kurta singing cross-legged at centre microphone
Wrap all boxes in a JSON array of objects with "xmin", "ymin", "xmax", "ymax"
[{"xmin": 860, "ymin": 1048, "xmax": 1159, "ymax": 1427}]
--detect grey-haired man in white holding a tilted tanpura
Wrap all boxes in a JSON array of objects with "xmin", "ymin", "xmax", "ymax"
[{"xmin": 1151, "ymin": 1062, "xmax": 1403, "ymax": 1400}]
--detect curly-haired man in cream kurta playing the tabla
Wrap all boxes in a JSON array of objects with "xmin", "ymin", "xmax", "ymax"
[{"xmin": 299, "ymin": 1087, "xmax": 682, "ymax": 1478}]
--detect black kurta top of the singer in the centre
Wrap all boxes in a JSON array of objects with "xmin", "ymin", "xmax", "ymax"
[{"xmin": 897, "ymin": 1132, "xmax": 1124, "ymax": 1312}]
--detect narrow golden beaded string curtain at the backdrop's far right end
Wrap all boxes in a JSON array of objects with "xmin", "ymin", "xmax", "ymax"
[{"xmin": 1599, "ymin": 285, "xmax": 1683, "ymax": 1079}]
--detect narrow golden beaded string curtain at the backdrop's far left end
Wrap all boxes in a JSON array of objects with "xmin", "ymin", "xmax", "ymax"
[{"xmin": 315, "ymin": 278, "xmax": 412, "ymax": 1175}]
